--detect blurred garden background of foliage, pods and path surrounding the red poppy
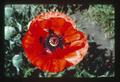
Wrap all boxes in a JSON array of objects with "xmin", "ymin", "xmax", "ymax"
[{"xmin": 4, "ymin": 4, "xmax": 115, "ymax": 78}]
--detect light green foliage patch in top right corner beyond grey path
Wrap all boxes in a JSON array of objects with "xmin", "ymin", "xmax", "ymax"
[{"xmin": 82, "ymin": 5, "xmax": 115, "ymax": 38}]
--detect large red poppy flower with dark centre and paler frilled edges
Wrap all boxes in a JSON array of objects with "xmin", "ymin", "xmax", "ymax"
[{"xmin": 22, "ymin": 12, "xmax": 88, "ymax": 72}]
